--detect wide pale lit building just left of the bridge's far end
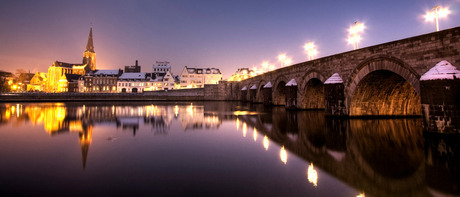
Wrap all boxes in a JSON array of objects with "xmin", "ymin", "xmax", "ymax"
[{"xmin": 180, "ymin": 66, "xmax": 222, "ymax": 88}]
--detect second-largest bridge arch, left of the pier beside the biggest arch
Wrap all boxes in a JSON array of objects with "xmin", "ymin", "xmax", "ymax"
[{"xmin": 298, "ymin": 70, "xmax": 326, "ymax": 109}]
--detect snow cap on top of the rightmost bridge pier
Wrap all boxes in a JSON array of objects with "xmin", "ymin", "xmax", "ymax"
[{"xmin": 420, "ymin": 60, "xmax": 460, "ymax": 81}]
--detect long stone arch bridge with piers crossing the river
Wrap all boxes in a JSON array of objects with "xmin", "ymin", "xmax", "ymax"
[{"xmin": 225, "ymin": 27, "xmax": 460, "ymax": 124}]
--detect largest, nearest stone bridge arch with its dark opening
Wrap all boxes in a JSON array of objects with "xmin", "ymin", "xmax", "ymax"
[{"xmin": 345, "ymin": 56, "xmax": 421, "ymax": 116}]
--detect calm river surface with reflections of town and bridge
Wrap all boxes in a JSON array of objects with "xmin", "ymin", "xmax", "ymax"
[{"xmin": 0, "ymin": 102, "xmax": 460, "ymax": 196}]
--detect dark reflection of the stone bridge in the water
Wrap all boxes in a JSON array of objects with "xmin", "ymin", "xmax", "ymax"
[{"xmin": 235, "ymin": 105, "xmax": 460, "ymax": 196}]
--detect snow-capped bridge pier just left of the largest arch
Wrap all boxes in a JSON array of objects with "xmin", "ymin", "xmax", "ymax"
[{"xmin": 324, "ymin": 73, "xmax": 348, "ymax": 116}]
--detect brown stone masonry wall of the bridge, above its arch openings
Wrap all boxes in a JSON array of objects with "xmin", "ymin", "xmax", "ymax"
[{"xmin": 231, "ymin": 27, "xmax": 460, "ymax": 114}]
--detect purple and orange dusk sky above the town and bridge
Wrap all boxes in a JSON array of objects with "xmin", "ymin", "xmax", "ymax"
[{"xmin": 0, "ymin": 0, "xmax": 460, "ymax": 79}]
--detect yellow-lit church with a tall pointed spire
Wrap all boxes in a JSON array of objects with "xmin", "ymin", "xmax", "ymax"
[{"xmin": 44, "ymin": 28, "xmax": 96, "ymax": 92}]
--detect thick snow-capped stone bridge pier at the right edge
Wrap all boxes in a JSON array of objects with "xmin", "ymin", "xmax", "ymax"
[{"xmin": 420, "ymin": 61, "xmax": 460, "ymax": 133}]
